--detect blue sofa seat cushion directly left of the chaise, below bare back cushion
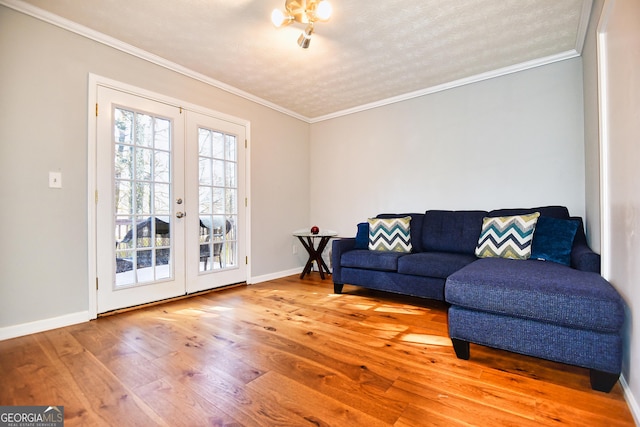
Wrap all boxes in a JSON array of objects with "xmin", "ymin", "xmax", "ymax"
[{"xmin": 398, "ymin": 252, "xmax": 477, "ymax": 279}]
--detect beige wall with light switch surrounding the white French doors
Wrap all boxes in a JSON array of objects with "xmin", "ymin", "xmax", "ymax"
[{"xmin": 0, "ymin": 6, "xmax": 309, "ymax": 329}]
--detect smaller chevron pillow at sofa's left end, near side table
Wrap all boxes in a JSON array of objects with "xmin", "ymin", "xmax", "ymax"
[{"xmin": 367, "ymin": 216, "xmax": 411, "ymax": 252}]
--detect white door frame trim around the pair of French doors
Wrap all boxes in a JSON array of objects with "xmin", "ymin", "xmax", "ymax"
[{"xmin": 87, "ymin": 73, "xmax": 251, "ymax": 319}]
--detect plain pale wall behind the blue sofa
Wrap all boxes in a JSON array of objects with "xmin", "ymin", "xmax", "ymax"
[{"xmin": 310, "ymin": 58, "xmax": 585, "ymax": 236}]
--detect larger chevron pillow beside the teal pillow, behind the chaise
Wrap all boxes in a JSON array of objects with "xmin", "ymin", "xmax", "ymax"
[{"xmin": 476, "ymin": 212, "xmax": 540, "ymax": 259}]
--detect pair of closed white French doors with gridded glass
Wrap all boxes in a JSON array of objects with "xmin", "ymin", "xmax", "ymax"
[{"xmin": 96, "ymin": 86, "xmax": 246, "ymax": 313}]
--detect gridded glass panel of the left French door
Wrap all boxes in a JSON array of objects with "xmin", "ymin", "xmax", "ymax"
[{"xmin": 113, "ymin": 108, "xmax": 173, "ymax": 288}]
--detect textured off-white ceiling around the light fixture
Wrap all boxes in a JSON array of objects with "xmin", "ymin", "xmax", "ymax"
[{"xmin": 5, "ymin": 0, "xmax": 592, "ymax": 121}]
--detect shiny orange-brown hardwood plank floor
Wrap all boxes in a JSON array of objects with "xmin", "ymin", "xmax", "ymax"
[{"xmin": 0, "ymin": 273, "xmax": 634, "ymax": 427}]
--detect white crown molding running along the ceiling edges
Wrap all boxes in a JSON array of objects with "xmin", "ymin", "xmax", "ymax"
[{"xmin": 0, "ymin": 0, "xmax": 593, "ymax": 124}]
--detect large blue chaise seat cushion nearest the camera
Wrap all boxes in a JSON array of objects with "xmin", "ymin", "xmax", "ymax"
[{"xmin": 445, "ymin": 258, "xmax": 624, "ymax": 333}]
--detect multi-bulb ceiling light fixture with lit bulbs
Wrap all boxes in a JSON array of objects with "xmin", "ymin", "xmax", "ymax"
[{"xmin": 271, "ymin": 0, "xmax": 333, "ymax": 49}]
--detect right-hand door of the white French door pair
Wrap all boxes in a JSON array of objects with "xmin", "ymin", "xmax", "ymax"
[{"xmin": 186, "ymin": 111, "xmax": 247, "ymax": 293}]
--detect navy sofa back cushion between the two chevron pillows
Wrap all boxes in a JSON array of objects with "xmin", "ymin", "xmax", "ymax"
[{"xmin": 422, "ymin": 210, "xmax": 488, "ymax": 255}]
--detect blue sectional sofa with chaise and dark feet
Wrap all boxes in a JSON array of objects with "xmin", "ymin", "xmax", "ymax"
[{"xmin": 332, "ymin": 206, "xmax": 625, "ymax": 392}]
